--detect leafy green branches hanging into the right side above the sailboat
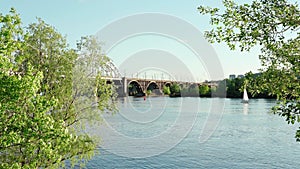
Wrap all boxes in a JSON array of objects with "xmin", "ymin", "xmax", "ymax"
[{"xmin": 198, "ymin": 0, "xmax": 300, "ymax": 141}]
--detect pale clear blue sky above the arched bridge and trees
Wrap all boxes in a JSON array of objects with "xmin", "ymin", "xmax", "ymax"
[{"xmin": 0, "ymin": 0, "xmax": 261, "ymax": 81}]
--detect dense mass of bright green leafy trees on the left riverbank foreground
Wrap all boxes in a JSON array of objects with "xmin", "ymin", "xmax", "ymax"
[{"xmin": 0, "ymin": 9, "xmax": 114, "ymax": 168}]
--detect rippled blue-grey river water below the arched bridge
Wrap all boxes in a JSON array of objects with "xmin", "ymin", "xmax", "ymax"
[{"xmin": 87, "ymin": 97, "xmax": 300, "ymax": 168}]
